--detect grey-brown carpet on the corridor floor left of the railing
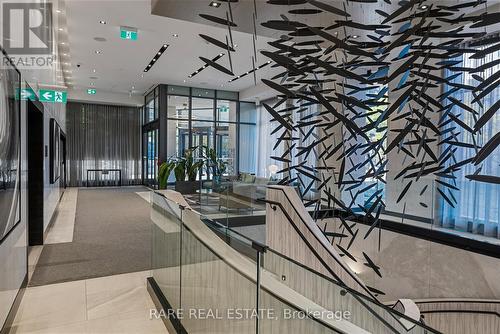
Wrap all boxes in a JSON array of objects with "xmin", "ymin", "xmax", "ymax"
[{"xmin": 29, "ymin": 187, "xmax": 153, "ymax": 286}]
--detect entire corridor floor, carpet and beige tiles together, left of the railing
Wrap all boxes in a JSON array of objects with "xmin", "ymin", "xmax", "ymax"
[{"xmin": 11, "ymin": 187, "xmax": 167, "ymax": 333}]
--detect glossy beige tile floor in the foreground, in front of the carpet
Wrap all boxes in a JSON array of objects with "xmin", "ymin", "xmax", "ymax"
[{"xmin": 11, "ymin": 271, "xmax": 167, "ymax": 334}]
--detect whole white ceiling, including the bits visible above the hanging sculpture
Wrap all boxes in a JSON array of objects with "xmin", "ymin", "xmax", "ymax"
[{"xmin": 62, "ymin": 0, "xmax": 492, "ymax": 102}]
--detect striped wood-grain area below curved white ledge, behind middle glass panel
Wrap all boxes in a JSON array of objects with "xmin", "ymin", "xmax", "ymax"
[{"xmin": 181, "ymin": 210, "xmax": 257, "ymax": 334}]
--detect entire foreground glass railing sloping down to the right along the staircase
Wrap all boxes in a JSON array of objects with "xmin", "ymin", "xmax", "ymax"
[{"xmin": 151, "ymin": 189, "xmax": 435, "ymax": 334}]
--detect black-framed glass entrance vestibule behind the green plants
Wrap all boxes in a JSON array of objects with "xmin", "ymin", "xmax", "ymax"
[{"xmin": 143, "ymin": 85, "xmax": 257, "ymax": 185}]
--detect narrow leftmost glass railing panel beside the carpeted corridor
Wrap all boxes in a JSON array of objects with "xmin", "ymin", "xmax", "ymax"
[{"xmin": 151, "ymin": 192, "xmax": 182, "ymax": 309}]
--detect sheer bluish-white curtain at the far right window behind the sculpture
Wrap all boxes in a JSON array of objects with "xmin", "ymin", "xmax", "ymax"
[{"xmin": 441, "ymin": 45, "xmax": 500, "ymax": 236}]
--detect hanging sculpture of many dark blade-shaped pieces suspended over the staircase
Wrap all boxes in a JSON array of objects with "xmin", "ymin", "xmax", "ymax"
[{"xmin": 196, "ymin": 0, "xmax": 500, "ymax": 293}]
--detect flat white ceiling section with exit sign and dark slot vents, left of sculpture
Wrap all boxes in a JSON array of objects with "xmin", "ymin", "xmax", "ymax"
[{"xmin": 65, "ymin": 0, "xmax": 286, "ymax": 95}]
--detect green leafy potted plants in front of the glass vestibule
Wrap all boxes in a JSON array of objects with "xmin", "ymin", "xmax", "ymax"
[{"xmin": 158, "ymin": 148, "xmax": 204, "ymax": 194}]
